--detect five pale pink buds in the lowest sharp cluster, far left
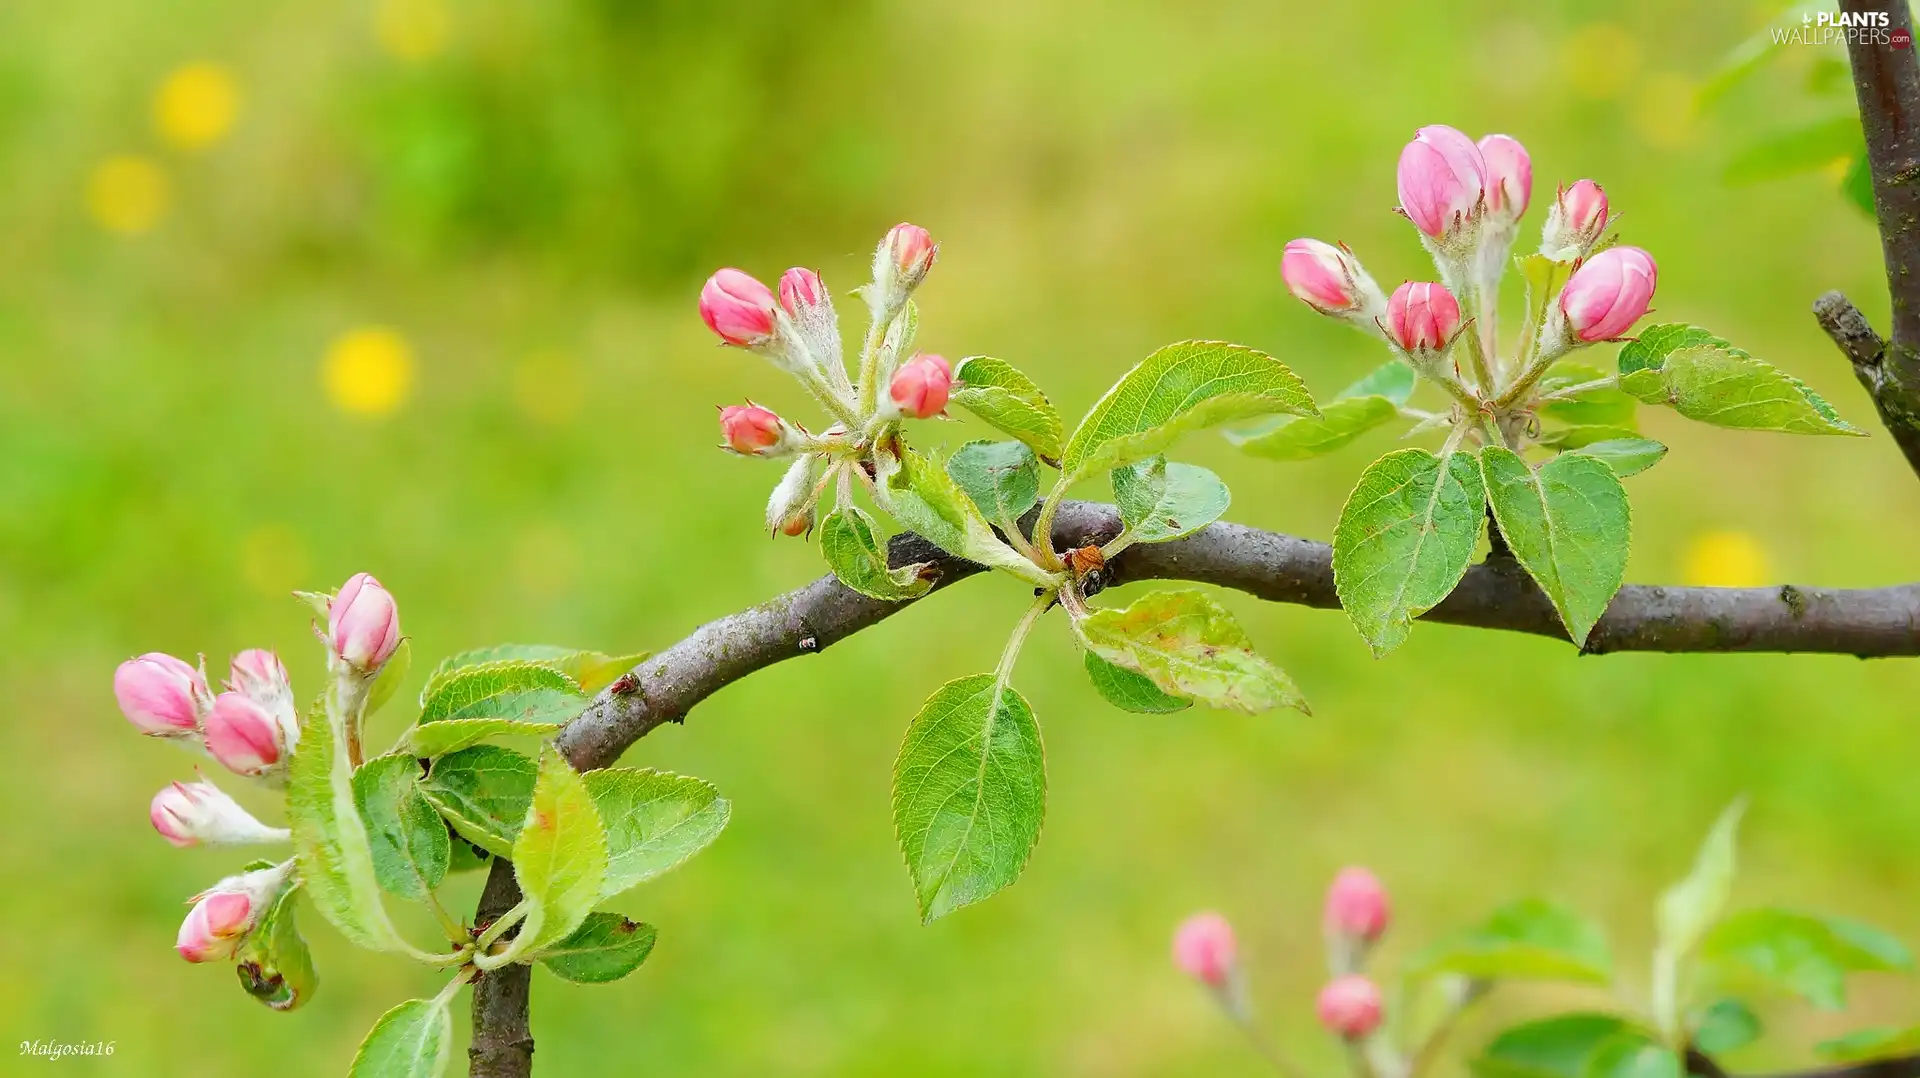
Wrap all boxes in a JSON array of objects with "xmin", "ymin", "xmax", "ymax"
[{"xmin": 113, "ymin": 573, "xmax": 401, "ymax": 963}]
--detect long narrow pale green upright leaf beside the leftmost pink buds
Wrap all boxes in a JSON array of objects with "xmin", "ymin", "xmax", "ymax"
[{"xmin": 286, "ymin": 698, "xmax": 403, "ymax": 951}]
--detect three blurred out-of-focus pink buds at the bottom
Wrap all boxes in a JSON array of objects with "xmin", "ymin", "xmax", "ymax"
[{"xmin": 1173, "ymin": 869, "xmax": 1392, "ymax": 1072}]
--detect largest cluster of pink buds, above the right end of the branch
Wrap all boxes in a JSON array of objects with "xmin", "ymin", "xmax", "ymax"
[{"xmin": 1281, "ymin": 125, "xmax": 1659, "ymax": 402}]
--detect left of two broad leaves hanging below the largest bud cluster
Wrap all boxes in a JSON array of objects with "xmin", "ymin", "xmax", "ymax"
[{"xmin": 1332, "ymin": 450, "xmax": 1486, "ymax": 657}]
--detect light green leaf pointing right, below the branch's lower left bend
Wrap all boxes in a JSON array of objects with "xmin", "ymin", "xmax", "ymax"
[{"xmin": 586, "ymin": 767, "xmax": 733, "ymax": 899}]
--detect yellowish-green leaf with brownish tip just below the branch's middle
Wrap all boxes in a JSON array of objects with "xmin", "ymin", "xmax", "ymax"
[{"xmin": 1075, "ymin": 590, "xmax": 1308, "ymax": 715}]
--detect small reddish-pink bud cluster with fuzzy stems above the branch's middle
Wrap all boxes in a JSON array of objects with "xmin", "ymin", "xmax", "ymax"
[{"xmin": 701, "ymin": 225, "xmax": 954, "ymax": 536}]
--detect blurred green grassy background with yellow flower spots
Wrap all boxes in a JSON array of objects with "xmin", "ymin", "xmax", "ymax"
[{"xmin": 0, "ymin": 0, "xmax": 1920, "ymax": 1078}]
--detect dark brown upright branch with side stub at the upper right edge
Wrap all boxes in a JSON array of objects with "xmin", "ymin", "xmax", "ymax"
[{"xmin": 1814, "ymin": 0, "xmax": 1920, "ymax": 475}]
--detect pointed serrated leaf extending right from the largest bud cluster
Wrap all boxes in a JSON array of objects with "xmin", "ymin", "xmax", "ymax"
[{"xmin": 1620, "ymin": 344, "xmax": 1864, "ymax": 436}]
